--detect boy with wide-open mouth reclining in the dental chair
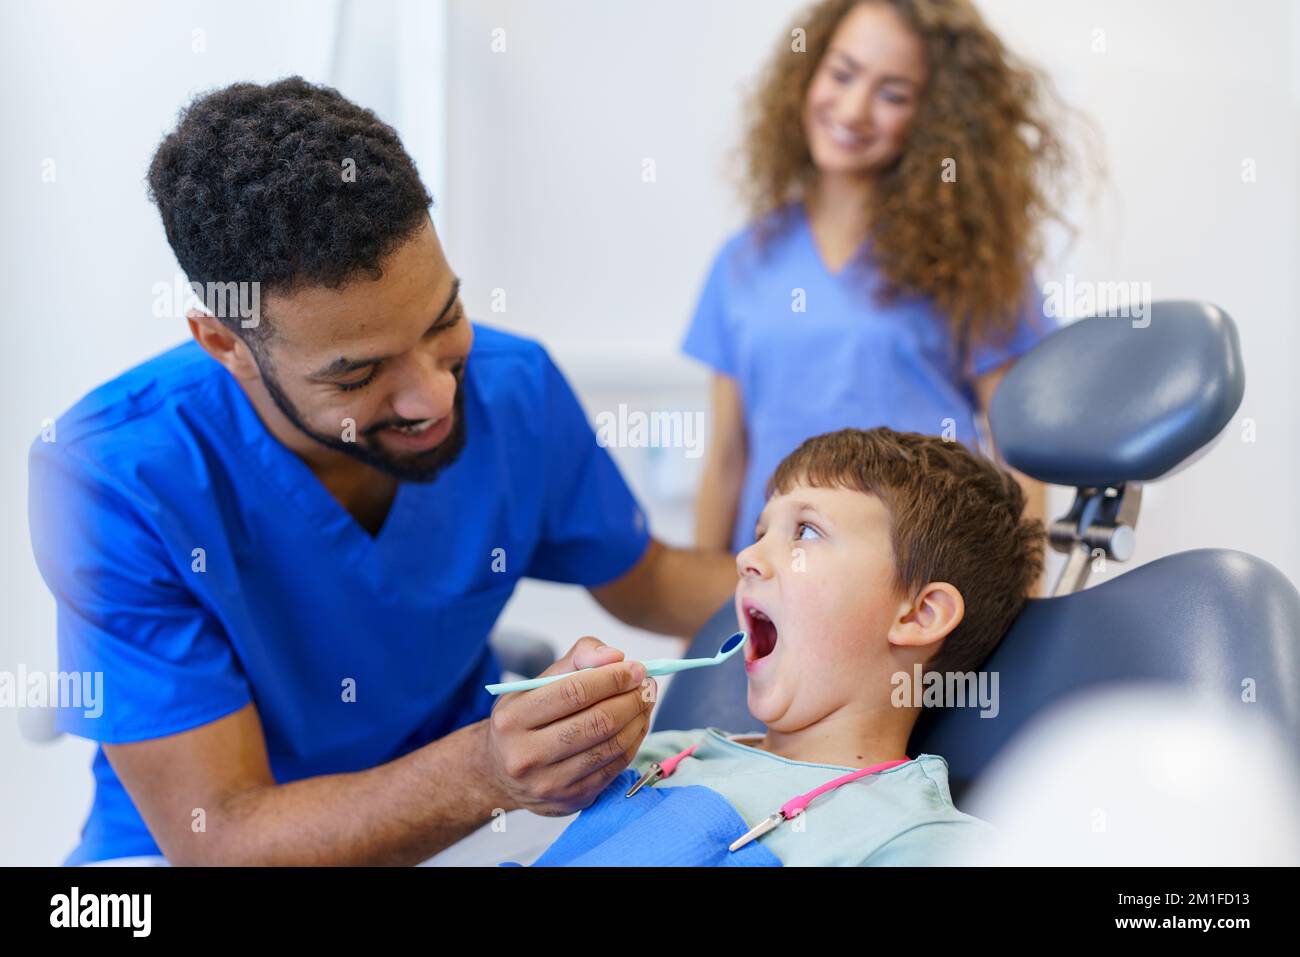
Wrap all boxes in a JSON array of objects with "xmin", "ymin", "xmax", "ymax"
[{"xmin": 509, "ymin": 428, "xmax": 1044, "ymax": 866}]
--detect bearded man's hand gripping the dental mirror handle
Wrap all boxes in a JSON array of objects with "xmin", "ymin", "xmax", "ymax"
[{"xmin": 488, "ymin": 636, "xmax": 659, "ymax": 817}]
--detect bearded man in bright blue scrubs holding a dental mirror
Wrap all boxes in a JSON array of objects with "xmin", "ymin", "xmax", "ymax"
[{"xmin": 30, "ymin": 78, "xmax": 736, "ymax": 865}]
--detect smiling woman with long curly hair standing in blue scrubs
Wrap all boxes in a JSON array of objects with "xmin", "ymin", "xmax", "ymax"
[{"xmin": 683, "ymin": 0, "xmax": 1081, "ymax": 564}]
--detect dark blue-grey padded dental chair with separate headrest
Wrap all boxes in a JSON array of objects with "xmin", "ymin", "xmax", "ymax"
[{"xmin": 654, "ymin": 302, "xmax": 1300, "ymax": 801}]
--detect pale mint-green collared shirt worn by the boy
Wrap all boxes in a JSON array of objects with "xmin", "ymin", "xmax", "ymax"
[{"xmin": 631, "ymin": 728, "xmax": 997, "ymax": 867}]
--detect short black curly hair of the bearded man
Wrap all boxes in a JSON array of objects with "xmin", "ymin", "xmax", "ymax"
[{"xmin": 148, "ymin": 77, "xmax": 433, "ymax": 339}]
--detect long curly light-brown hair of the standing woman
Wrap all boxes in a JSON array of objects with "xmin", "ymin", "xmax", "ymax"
[{"xmin": 744, "ymin": 0, "xmax": 1100, "ymax": 371}]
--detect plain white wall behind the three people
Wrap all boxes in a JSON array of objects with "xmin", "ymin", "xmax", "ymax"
[{"xmin": 0, "ymin": 0, "xmax": 1300, "ymax": 863}]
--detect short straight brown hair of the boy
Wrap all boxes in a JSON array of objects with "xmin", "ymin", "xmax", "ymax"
[{"xmin": 767, "ymin": 426, "xmax": 1045, "ymax": 672}]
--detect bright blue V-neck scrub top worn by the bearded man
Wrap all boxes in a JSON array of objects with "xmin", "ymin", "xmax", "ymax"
[{"xmin": 30, "ymin": 325, "xmax": 649, "ymax": 863}]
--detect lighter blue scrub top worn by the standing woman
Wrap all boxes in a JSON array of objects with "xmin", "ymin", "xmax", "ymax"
[{"xmin": 683, "ymin": 203, "xmax": 1060, "ymax": 551}]
